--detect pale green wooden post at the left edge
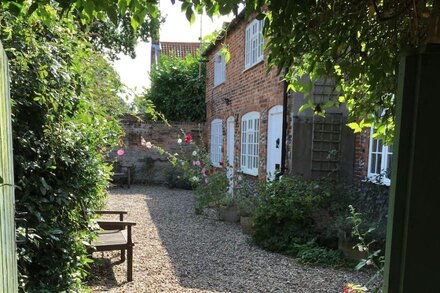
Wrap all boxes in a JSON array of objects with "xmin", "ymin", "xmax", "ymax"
[{"xmin": 0, "ymin": 43, "xmax": 18, "ymax": 293}]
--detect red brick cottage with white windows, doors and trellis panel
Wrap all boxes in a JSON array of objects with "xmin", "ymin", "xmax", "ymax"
[{"xmin": 203, "ymin": 12, "xmax": 392, "ymax": 184}]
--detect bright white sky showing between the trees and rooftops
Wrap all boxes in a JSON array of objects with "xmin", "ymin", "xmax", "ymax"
[{"xmin": 113, "ymin": 0, "xmax": 232, "ymax": 100}]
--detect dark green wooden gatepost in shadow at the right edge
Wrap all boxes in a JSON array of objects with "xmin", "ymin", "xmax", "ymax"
[{"xmin": 384, "ymin": 44, "xmax": 440, "ymax": 293}]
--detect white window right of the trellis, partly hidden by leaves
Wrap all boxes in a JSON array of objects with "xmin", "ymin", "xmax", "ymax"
[{"xmin": 368, "ymin": 128, "xmax": 393, "ymax": 185}]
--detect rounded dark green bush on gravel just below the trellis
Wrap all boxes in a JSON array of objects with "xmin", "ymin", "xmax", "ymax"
[{"xmin": 252, "ymin": 177, "xmax": 338, "ymax": 253}]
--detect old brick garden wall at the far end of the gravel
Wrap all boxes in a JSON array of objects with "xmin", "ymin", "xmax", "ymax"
[{"xmin": 112, "ymin": 116, "xmax": 204, "ymax": 184}]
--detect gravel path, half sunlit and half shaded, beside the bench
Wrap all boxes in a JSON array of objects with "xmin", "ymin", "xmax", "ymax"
[{"xmin": 88, "ymin": 186, "xmax": 365, "ymax": 293}]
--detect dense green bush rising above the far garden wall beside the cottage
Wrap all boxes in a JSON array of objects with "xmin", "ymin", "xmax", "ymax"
[{"xmin": 139, "ymin": 55, "xmax": 205, "ymax": 121}]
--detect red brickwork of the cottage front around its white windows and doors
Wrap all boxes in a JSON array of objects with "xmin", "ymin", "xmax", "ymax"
[{"xmin": 205, "ymin": 20, "xmax": 283, "ymax": 178}]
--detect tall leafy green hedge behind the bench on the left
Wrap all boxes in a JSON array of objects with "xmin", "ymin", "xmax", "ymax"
[{"xmin": 0, "ymin": 12, "xmax": 121, "ymax": 292}]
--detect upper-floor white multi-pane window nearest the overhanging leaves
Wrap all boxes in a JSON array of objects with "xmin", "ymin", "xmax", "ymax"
[{"xmin": 245, "ymin": 19, "xmax": 264, "ymax": 69}]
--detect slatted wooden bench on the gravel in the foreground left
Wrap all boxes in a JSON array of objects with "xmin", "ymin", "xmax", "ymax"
[{"xmin": 92, "ymin": 211, "xmax": 136, "ymax": 282}]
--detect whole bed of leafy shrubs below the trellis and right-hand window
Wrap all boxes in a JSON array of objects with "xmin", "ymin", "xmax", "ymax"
[{"xmin": 252, "ymin": 176, "xmax": 387, "ymax": 267}]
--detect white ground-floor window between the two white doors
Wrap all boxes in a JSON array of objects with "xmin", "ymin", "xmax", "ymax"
[{"xmin": 241, "ymin": 112, "xmax": 260, "ymax": 175}]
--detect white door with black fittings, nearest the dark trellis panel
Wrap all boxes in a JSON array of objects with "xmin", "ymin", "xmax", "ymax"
[{"xmin": 266, "ymin": 105, "xmax": 283, "ymax": 180}]
